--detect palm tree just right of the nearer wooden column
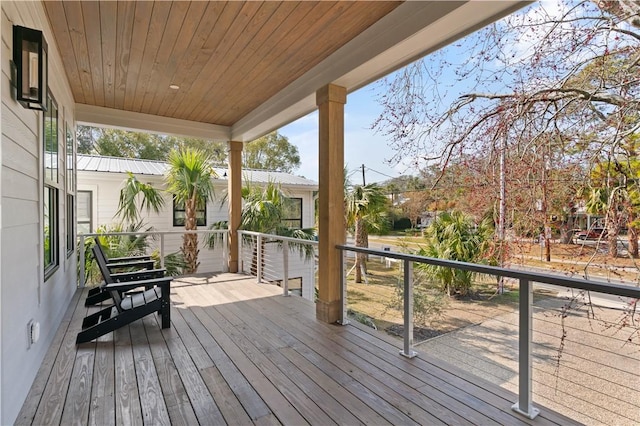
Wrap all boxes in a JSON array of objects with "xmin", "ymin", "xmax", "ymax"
[{"xmin": 345, "ymin": 179, "xmax": 389, "ymax": 283}]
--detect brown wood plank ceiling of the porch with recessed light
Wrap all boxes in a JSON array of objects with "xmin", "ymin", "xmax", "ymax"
[{"xmin": 44, "ymin": 1, "xmax": 401, "ymax": 126}]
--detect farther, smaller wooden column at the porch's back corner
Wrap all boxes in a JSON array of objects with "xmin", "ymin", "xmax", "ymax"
[{"xmin": 227, "ymin": 141, "xmax": 242, "ymax": 272}]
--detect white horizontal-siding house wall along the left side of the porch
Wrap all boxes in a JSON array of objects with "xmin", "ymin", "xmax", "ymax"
[{"xmin": 0, "ymin": 0, "xmax": 76, "ymax": 424}]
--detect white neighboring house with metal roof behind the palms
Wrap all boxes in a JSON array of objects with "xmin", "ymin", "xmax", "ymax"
[{"xmin": 77, "ymin": 155, "xmax": 318, "ymax": 299}]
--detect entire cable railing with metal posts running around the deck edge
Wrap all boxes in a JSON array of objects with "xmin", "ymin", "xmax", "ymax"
[{"xmin": 74, "ymin": 230, "xmax": 640, "ymax": 424}]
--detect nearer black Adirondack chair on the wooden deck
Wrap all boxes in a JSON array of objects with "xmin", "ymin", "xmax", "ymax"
[{"xmin": 76, "ymin": 246, "xmax": 173, "ymax": 344}]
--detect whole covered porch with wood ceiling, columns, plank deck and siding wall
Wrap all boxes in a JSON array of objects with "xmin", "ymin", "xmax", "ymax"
[{"xmin": 0, "ymin": 0, "xmax": 540, "ymax": 424}]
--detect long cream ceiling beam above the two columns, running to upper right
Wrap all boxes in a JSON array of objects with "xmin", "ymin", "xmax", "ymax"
[{"xmin": 231, "ymin": 1, "xmax": 532, "ymax": 142}]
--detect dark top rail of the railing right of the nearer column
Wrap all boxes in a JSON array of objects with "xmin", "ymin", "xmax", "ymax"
[{"xmin": 336, "ymin": 245, "xmax": 640, "ymax": 299}]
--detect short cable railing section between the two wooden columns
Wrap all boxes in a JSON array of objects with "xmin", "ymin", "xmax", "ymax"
[{"xmin": 238, "ymin": 231, "xmax": 318, "ymax": 301}]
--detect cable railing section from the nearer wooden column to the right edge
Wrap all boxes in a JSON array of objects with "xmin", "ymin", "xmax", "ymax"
[{"xmin": 336, "ymin": 245, "xmax": 640, "ymax": 424}]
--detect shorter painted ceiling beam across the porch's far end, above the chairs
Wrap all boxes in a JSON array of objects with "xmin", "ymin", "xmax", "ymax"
[{"xmin": 75, "ymin": 104, "xmax": 231, "ymax": 142}]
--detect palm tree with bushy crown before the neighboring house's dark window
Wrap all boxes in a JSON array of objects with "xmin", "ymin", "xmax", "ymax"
[{"xmin": 165, "ymin": 148, "xmax": 217, "ymax": 274}]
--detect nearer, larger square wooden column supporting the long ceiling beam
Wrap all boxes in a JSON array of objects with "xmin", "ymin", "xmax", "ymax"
[{"xmin": 316, "ymin": 84, "xmax": 347, "ymax": 323}]
